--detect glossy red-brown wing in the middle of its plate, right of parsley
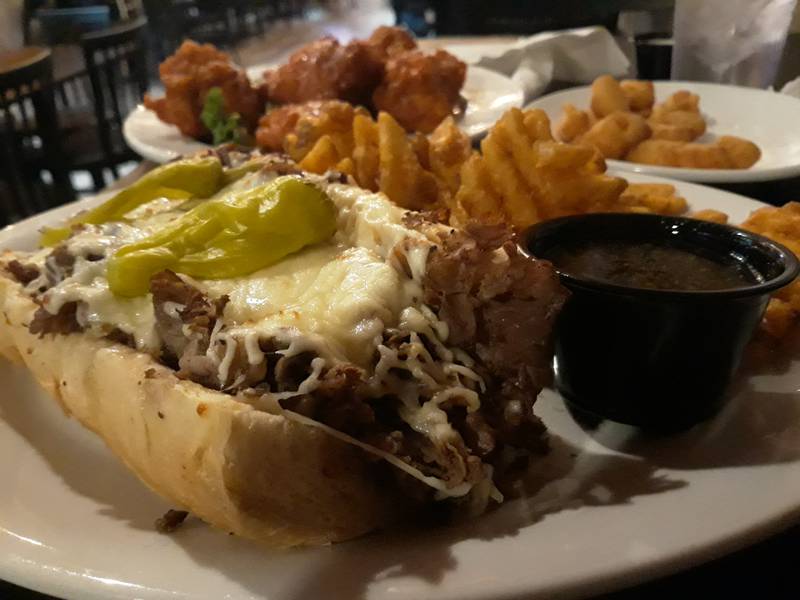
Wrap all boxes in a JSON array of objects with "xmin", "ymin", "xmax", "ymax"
[{"xmin": 263, "ymin": 37, "xmax": 383, "ymax": 104}]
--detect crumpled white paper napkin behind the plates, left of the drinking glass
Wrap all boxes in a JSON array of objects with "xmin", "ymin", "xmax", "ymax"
[{"xmin": 446, "ymin": 27, "xmax": 631, "ymax": 100}]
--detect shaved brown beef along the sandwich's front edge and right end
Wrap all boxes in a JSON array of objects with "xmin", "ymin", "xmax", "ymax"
[{"xmin": 141, "ymin": 217, "xmax": 566, "ymax": 500}]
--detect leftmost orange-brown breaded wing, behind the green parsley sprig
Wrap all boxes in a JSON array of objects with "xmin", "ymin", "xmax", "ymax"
[{"xmin": 144, "ymin": 40, "xmax": 264, "ymax": 140}]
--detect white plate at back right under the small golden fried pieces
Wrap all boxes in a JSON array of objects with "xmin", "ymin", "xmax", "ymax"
[{"xmin": 528, "ymin": 81, "xmax": 800, "ymax": 183}]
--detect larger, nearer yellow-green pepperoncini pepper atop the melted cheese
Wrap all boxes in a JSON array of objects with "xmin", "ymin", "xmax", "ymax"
[{"xmin": 107, "ymin": 176, "xmax": 336, "ymax": 297}]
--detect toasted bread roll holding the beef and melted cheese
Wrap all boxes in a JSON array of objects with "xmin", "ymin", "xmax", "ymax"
[{"xmin": 0, "ymin": 276, "xmax": 402, "ymax": 546}]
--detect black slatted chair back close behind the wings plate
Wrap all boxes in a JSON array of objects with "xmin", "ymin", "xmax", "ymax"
[{"xmin": 81, "ymin": 17, "xmax": 148, "ymax": 168}]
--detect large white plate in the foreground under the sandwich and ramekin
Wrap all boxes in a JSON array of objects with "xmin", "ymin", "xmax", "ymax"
[{"xmin": 0, "ymin": 175, "xmax": 800, "ymax": 600}]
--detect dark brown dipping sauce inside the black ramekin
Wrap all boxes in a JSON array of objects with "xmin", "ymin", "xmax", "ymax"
[{"xmin": 548, "ymin": 240, "xmax": 758, "ymax": 291}]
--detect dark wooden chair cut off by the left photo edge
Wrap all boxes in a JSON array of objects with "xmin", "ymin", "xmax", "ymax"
[{"xmin": 0, "ymin": 48, "xmax": 75, "ymax": 222}]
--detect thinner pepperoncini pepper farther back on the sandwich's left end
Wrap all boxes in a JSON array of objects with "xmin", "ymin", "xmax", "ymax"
[{"xmin": 41, "ymin": 157, "xmax": 227, "ymax": 246}]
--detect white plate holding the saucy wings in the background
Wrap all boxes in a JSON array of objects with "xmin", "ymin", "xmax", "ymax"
[{"xmin": 122, "ymin": 65, "xmax": 525, "ymax": 163}]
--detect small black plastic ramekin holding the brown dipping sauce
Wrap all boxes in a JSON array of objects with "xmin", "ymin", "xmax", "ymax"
[{"xmin": 521, "ymin": 213, "xmax": 800, "ymax": 431}]
